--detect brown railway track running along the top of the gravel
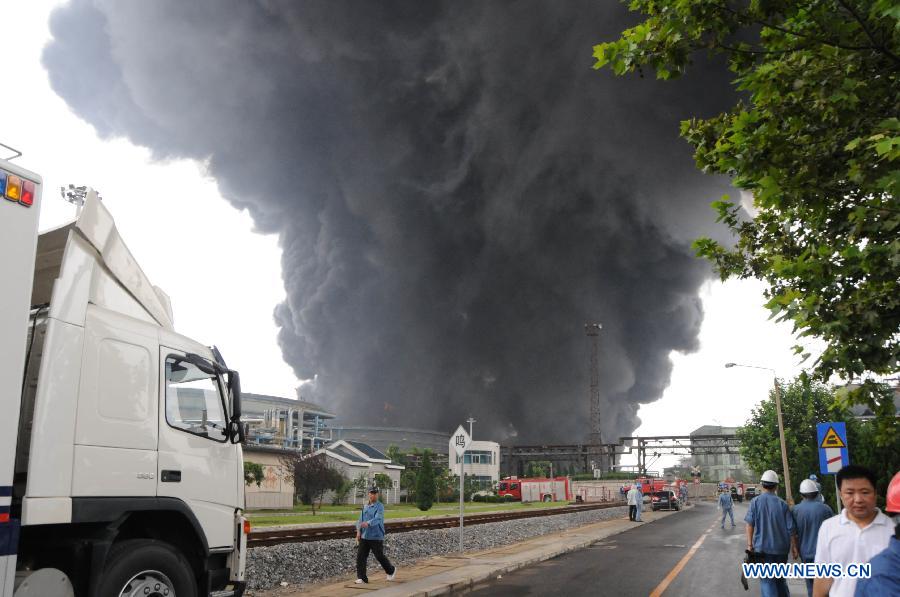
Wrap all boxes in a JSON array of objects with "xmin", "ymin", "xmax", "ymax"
[{"xmin": 247, "ymin": 502, "xmax": 625, "ymax": 547}]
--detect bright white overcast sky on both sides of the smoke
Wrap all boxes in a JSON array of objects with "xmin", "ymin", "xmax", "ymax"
[{"xmin": 0, "ymin": 1, "xmax": 816, "ymax": 464}]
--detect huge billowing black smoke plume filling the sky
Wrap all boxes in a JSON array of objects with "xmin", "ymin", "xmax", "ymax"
[{"xmin": 44, "ymin": 0, "xmax": 732, "ymax": 443}]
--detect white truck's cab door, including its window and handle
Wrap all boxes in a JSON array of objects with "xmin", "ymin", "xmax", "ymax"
[{"xmin": 157, "ymin": 347, "xmax": 242, "ymax": 548}]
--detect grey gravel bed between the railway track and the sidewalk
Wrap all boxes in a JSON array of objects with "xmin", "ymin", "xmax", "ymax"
[{"xmin": 246, "ymin": 506, "xmax": 628, "ymax": 590}]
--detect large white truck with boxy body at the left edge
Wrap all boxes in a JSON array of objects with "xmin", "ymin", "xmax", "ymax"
[{"xmin": 0, "ymin": 160, "xmax": 249, "ymax": 597}]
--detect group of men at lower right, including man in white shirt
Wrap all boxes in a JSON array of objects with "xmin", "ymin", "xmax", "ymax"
[{"xmin": 732, "ymin": 465, "xmax": 900, "ymax": 597}]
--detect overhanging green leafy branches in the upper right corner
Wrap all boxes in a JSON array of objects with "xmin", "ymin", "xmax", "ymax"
[{"xmin": 594, "ymin": 0, "xmax": 900, "ymax": 400}]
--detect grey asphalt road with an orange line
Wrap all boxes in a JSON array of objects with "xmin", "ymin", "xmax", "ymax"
[{"xmin": 458, "ymin": 502, "xmax": 806, "ymax": 597}]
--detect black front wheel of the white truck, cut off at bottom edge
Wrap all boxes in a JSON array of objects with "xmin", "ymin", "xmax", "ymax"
[{"xmin": 97, "ymin": 539, "xmax": 197, "ymax": 597}]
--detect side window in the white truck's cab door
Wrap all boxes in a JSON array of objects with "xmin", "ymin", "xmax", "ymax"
[{"xmin": 166, "ymin": 356, "xmax": 227, "ymax": 442}]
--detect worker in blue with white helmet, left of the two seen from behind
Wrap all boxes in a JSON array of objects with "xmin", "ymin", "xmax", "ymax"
[{"xmin": 744, "ymin": 471, "xmax": 797, "ymax": 597}]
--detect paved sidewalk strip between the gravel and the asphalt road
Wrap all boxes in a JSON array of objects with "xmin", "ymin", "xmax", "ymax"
[{"xmin": 253, "ymin": 506, "xmax": 693, "ymax": 597}]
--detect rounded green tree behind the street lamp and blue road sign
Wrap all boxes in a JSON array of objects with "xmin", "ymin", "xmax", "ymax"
[{"xmin": 737, "ymin": 379, "xmax": 900, "ymax": 508}]
